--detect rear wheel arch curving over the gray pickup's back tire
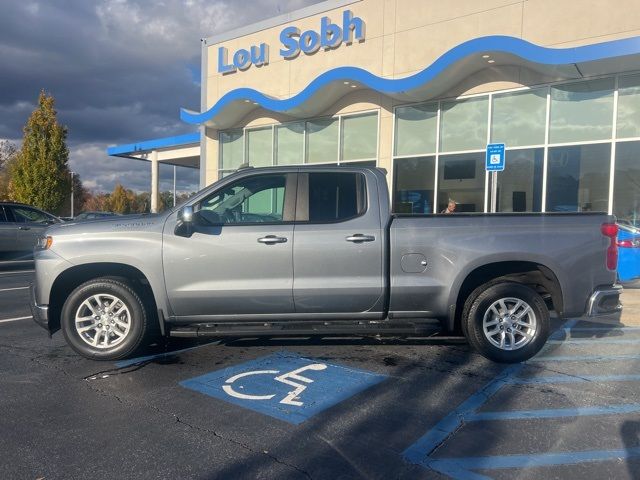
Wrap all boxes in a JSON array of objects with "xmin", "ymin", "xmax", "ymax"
[{"xmin": 447, "ymin": 260, "xmax": 564, "ymax": 331}]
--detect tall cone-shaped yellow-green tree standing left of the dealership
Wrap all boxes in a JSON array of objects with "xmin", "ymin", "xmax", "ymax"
[{"xmin": 9, "ymin": 90, "xmax": 71, "ymax": 213}]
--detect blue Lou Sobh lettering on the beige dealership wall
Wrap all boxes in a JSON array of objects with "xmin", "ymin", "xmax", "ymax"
[{"xmin": 218, "ymin": 10, "xmax": 365, "ymax": 74}]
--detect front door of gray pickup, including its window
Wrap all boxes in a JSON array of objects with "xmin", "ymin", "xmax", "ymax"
[{"xmin": 163, "ymin": 173, "xmax": 296, "ymax": 317}]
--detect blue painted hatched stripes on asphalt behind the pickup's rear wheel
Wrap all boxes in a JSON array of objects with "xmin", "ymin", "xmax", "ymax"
[{"xmin": 403, "ymin": 319, "xmax": 640, "ymax": 480}]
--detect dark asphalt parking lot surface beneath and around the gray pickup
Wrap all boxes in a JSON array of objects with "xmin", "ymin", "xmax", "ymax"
[{"xmin": 0, "ymin": 265, "xmax": 640, "ymax": 479}]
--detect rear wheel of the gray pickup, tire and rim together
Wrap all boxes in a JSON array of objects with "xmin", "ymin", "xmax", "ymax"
[{"xmin": 462, "ymin": 280, "xmax": 550, "ymax": 363}]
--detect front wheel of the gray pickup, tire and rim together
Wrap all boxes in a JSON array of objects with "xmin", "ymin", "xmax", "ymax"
[{"xmin": 60, "ymin": 277, "xmax": 151, "ymax": 360}]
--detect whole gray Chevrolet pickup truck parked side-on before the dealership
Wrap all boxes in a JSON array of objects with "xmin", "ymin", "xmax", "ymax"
[{"xmin": 32, "ymin": 166, "xmax": 621, "ymax": 362}]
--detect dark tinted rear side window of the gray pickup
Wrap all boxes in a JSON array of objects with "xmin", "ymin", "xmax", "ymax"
[{"xmin": 298, "ymin": 172, "xmax": 366, "ymax": 222}]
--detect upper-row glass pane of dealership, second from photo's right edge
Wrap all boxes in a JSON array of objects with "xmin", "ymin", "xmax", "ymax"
[{"xmin": 549, "ymin": 78, "xmax": 613, "ymax": 143}]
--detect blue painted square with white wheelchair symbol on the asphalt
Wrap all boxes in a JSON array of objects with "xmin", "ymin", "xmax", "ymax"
[{"xmin": 180, "ymin": 352, "xmax": 387, "ymax": 424}]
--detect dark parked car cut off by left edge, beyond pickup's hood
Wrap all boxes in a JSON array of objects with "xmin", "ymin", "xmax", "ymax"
[{"xmin": 0, "ymin": 202, "xmax": 62, "ymax": 259}]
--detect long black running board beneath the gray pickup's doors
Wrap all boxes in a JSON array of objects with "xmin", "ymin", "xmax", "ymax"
[{"xmin": 167, "ymin": 319, "xmax": 441, "ymax": 337}]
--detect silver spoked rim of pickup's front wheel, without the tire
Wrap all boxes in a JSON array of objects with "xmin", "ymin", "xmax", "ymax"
[{"xmin": 75, "ymin": 293, "xmax": 131, "ymax": 350}]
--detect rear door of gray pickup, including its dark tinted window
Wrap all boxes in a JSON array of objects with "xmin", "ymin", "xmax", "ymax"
[{"xmin": 293, "ymin": 167, "xmax": 385, "ymax": 317}]
